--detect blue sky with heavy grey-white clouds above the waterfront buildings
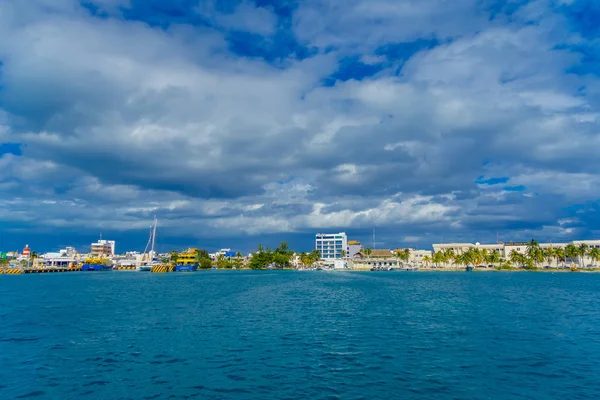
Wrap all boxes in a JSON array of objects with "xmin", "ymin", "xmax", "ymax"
[{"xmin": 0, "ymin": 0, "xmax": 600, "ymax": 251}]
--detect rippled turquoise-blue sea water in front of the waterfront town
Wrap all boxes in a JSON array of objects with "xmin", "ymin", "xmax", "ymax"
[{"xmin": 0, "ymin": 271, "xmax": 600, "ymax": 399}]
